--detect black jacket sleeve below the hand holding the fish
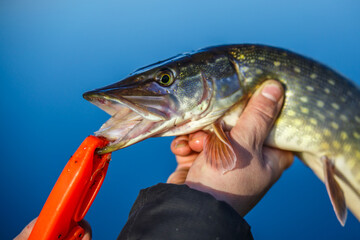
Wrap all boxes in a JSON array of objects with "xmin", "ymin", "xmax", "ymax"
[{"xmin": 118, "ymin": 184, "xmax": 253, "ymax": 240}]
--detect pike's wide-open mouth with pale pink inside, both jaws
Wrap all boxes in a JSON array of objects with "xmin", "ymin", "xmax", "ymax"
[{"xmin": 83, "ymin": 91, "xmax": 171, "ymax": 154}]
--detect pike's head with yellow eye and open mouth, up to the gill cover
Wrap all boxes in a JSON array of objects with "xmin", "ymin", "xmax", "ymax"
[{"xmin": 83, "ymin": 49, "xmax": 236, "ymax": 153}]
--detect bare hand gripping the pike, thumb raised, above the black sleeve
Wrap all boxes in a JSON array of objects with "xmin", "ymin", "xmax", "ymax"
[{"xmin": 168, "ymin": 80, "xmax": 293, "ymax": 216}]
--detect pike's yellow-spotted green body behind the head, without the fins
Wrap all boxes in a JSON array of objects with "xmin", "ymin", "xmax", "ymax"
[{"xmin": 224, "ymin": 45, "xmax": 360, "ymax": 223}]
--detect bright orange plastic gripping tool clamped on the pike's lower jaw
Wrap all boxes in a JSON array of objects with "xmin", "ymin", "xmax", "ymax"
[{"xmin": 29, "ymin": 136, "xmax": 111, "ymax": 240}]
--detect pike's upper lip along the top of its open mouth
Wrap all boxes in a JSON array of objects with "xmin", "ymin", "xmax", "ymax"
[{"xmin": 83, "ymin": 90, "xmax": 169, "ymax": 122}]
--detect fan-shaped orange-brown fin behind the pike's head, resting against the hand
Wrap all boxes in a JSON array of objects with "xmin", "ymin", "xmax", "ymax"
[{"xmin": 204, "ymin": 121, "xmax": 237, "ymax": 173}]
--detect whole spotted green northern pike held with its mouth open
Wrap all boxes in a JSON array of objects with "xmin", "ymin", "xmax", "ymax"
[{"xmin": 84, "ymin": 44, "xmax": 360, "ymax": 225}]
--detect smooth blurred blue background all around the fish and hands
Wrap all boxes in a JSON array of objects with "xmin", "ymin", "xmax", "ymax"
[{"xmin": 0, "ymin": 0, "xmax": 360, "ymax": 239}]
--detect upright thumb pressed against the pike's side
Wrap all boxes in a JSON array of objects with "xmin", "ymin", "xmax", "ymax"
[{"xmin": 230, "ymin": 80, "xmax": 284, "ymax": 147}]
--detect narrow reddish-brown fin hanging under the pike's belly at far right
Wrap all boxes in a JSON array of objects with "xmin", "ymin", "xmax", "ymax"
[{"xmin": 321, "ymin": 156, "xmax": 347, "ymax": 226}]
